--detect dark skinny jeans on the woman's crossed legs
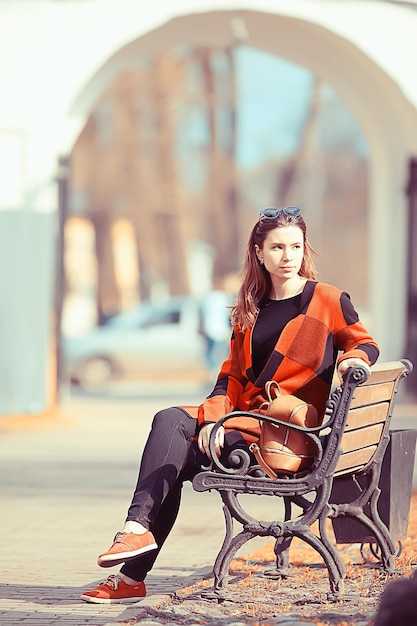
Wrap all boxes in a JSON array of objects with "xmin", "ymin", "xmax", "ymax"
[{"xmin": 121, "ymin": 407, "xmax": 248, "ymax": 581}]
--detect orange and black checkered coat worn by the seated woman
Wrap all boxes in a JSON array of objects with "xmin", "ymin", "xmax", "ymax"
[{"xmin": 198, "ymin": 281, "xmax": 378, "ymax": 441}]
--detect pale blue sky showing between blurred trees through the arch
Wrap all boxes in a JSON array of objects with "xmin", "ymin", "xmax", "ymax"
[{"xmin": 179, "ymin": 46, "xmax": 367, "ymax": 187}]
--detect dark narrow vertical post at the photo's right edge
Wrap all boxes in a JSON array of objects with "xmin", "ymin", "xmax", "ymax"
[{"xmin": 405, "ymin": 157, "xmax": 417, "ymax": 396}]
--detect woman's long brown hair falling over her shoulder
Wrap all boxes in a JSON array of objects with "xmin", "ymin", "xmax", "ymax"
[{"xmin": 231, "ymin": 211, "xmax": 318, "ymax": 331}]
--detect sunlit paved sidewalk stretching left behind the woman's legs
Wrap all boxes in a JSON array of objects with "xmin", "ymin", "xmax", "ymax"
[{"xmin": 0, "ymin": 389, "xmax": 417, "ymax": 626}]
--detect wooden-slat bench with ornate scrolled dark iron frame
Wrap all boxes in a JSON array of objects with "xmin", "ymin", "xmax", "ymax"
[{"xmin": 193, "ymin": 360, "xmax": 414, "ymax": 601}]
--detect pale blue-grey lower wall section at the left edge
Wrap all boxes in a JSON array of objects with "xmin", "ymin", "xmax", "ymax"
[{"xmin": 0, "ymin": 210, "xmax": 57, "ymax": 415}]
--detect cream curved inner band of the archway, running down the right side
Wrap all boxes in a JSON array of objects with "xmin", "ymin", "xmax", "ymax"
[{"xmin": 66, "ymin": 11, "xmax": 417, "ymax": 358}]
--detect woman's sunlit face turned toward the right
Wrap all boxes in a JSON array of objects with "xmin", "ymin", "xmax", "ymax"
[{"xmin": 255, "ymin": 226, "xmax": 304, "ymax": 281}]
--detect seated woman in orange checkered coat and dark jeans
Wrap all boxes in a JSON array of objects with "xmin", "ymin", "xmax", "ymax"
[{"xmin": 81, "ymin": 207, "xmax": 379, "ymax": 603}]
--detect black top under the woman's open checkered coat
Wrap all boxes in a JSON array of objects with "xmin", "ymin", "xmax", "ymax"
[{"xmin": 252, "ymin": 293, "xmax": 302, "ymax": 377}]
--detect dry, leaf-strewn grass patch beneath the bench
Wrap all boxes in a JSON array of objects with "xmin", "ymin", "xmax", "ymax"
[{"xmin": 171, "ymin": 492, "xmax": 417, "ymax": 626}]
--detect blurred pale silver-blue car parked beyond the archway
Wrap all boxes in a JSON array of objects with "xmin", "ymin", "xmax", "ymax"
[{"xmin": 62, "ymin": 296, "xmax": 205, "ymax": 388}]
